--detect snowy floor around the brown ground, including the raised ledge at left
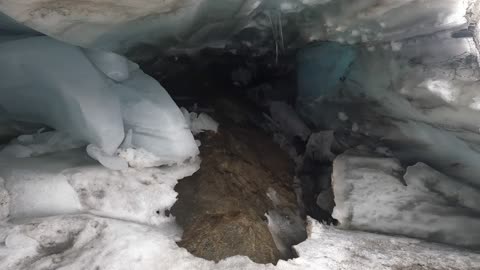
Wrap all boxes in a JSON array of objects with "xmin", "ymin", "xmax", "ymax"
[{"xmin": 0, "ymin": 142, "xmax": 480, "ymax": 270}]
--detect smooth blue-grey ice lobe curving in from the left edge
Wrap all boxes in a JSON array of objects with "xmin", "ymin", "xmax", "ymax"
[{"xmin": 0, "ymin": 37, "xmax": 124, "ymax": 154}]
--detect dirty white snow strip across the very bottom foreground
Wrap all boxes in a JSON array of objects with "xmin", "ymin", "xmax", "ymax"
[{"xmin": 0, "ymin": 215, "xmax": 480, "ymax": 270}]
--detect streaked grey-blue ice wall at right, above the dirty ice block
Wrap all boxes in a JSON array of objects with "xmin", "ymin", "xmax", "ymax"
[{"xmin": 297, "ymin": 30, "xmax": 480, "ymax": 187}]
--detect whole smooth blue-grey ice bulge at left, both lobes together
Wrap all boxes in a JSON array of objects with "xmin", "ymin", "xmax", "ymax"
[{"xmin": 0, "ymin": 36, "xmax": 198, "ymax": 169}]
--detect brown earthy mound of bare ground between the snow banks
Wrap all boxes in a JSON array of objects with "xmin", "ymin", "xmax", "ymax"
[{"xmin": 172, "ymin": 115, "xmax": 306, "ymax": 263}]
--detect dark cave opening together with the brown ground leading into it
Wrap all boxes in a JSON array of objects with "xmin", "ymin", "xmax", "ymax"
[{"xmin": 141, "ymin": 49, "xmax": 342, "ymax": 263}]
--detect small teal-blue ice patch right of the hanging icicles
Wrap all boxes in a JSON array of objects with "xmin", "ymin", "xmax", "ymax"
[{"xmin": 297, "ymin": 42, "xmax": 356, "ymax": 99}]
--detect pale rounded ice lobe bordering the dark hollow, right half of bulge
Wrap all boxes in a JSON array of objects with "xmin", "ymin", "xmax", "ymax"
[{"xmin": 113, "ymin": 69, "xmax": 198, "ymax": 164}]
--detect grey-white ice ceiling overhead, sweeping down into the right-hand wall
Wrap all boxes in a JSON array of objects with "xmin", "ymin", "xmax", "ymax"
[{"xmin": 0, "ymin": 0, "xmax": 480, "ymax": 177}]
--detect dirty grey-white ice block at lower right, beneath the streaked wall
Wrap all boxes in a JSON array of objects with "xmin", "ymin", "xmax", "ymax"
[{"xmin": 332, "ymin": 150, "xmax": 480, "ymax": 248}]
